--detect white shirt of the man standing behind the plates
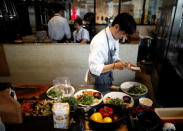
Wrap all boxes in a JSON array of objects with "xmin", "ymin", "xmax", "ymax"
[{"xmin": 88, "ymin": 27, "xmax": 120, "ymax": 76}]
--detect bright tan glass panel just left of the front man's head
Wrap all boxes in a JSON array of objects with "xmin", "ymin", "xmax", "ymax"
[{"xmin": 96, "ymin": 0, "xmax": 119, "ymax": 24}]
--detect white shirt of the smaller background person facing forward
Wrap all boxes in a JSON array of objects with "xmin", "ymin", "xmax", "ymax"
[{"xmin": 73, "ymin": 27, "xmax": 90, "ymax": 42}]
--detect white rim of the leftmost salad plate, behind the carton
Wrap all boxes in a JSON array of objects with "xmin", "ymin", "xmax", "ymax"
[{"xmin": 46, "ymin": 85, "xmax": 75, "ymax": 99}]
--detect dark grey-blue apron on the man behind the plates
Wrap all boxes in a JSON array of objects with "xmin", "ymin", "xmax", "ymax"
[{"xmin": 91, "ymin": 30, "xmax": 116, "ymax": 85}]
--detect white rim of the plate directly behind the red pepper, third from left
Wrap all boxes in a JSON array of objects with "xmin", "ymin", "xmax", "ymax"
[{"xmin": 103, "ymin": 91, "xmax": 134, "ymax": 107}]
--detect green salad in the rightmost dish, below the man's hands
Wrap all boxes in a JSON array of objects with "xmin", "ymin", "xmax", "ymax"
[{"xmin": 128, "ymin": 85, "xmax": 146, "ymax": 95}]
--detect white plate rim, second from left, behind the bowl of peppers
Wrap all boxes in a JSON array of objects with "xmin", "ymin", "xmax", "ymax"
[{"xmin": 74, "ymin": 89, "xmax": 103, "ymax": 106}]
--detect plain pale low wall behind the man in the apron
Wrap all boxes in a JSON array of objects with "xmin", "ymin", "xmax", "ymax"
[{"xmin": 0, "ymin": 44, "xmax": 138, "ymax": 85}]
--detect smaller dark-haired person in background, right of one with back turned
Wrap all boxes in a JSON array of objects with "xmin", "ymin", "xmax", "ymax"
[{"xmin": 73, "ymin": 17, "xmax": 90, "ymax": 44}]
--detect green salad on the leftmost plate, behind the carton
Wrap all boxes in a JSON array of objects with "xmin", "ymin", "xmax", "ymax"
[{"xmin": 47, "ymin": 87, "xmax": 63, "ymax": 99}]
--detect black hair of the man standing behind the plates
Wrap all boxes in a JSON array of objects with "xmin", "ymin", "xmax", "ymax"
[{"xmin": 112, "ymin": 13, "xmax": 136, "ymax": 34}]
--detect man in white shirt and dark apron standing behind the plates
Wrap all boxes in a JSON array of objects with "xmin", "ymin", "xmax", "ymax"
[{"xmin": 85, "ymin": 13, "xmax": 136, "ymax": 85}]
